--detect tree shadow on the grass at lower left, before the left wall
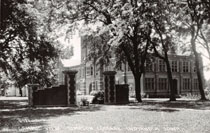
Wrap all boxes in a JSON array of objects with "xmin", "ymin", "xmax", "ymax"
[{"xmin": 0, "ymin": 100, "xmax": 101, "ymax": 133}]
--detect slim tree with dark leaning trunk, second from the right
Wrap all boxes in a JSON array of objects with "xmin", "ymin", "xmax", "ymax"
[{"xmin": 145, "ymin": 0, "xmax": 180, "ymax": 101}]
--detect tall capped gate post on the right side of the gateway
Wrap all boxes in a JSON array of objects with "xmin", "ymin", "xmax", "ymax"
[{"xmin": 103, "ymin": 71, "xmax": 116, "ymax": 104}]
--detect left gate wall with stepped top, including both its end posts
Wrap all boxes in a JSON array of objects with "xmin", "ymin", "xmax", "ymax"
[{"xmin": 28, "ymin": 70, "xmax": 77, "ymax": 106}]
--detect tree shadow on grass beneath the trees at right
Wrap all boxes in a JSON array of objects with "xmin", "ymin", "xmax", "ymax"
[{"xmin": 129, "ymin": 100, "xmax": 210, "ymax": 112}]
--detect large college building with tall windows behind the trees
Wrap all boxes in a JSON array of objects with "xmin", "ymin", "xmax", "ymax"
[{"xmin": 57, "ymin": 35, "xmax": 203, "ymax": 97}]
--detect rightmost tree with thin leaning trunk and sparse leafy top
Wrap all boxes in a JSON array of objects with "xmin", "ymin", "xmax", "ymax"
[{"xmin": 177, "ymin": 0, "xmax": 206, "ymax": 100}]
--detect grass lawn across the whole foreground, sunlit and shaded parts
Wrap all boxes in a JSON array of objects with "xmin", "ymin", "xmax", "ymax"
[{"xmin": 0, "ymin": 96, "xmax": 210, "ymax": 133}]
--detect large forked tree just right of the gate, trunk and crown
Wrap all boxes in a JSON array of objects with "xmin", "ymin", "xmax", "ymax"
[{"xmin": 44, "ymin": 0, "xmax": 156, "ymax": 102}]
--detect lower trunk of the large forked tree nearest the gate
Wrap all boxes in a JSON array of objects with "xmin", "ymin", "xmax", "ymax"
[{"xmin": 134, "ymin": 74, "xmax": 142, "ymax": 102}]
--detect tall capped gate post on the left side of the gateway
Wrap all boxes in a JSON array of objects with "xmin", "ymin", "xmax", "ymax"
[{"xmin": 63, "ymin": 70, "xmax": 77, "ymax": 106}]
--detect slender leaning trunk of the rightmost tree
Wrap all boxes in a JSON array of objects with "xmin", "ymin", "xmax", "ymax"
[{"xmin": 191, "ymin": 38, "xmax": 207, "ymax": 100}]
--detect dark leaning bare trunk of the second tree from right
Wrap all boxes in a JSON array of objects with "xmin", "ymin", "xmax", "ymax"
[{"xmin": 165, "ymin": 57, "xmax": 176, "ymax": 101}]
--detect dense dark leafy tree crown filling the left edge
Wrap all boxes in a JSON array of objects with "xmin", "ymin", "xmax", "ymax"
[{"xmin": 0, "ymin": 0, "xmax": 58, "ymax": 93}]
